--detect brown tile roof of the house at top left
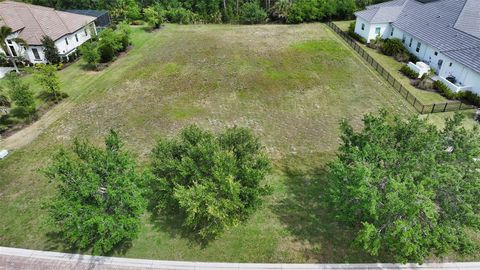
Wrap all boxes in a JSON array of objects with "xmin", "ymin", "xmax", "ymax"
[{"xmin": 0, "ymin": 1, "xmax": 96, "ymax": 45}]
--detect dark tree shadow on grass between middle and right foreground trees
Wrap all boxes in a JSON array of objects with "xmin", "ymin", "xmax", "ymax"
[{"xmin": 274, "ymin": 156, "xmax": 391, "ymax": 263}]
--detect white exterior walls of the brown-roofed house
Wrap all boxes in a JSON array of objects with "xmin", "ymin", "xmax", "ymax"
[{"xmin": 0, "ymin": 23, "xmax": 96, "ymax": 64}]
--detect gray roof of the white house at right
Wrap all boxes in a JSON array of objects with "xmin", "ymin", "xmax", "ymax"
[{"xmin": 356, "ymin": 0, "xmax": 480, "ymax": 72}]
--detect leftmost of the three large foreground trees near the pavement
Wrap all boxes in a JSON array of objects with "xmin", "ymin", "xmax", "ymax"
[{"xmin": 44, "ymin": 131, "xmax": 146, "ymax": 254}]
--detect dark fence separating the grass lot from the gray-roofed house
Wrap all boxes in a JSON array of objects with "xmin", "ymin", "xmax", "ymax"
[{"xmin": 327, "ymin": 22, "xmax": 475, "ymax": 114}]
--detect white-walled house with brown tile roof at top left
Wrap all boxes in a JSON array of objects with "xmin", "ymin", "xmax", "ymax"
[{"xmin": 0, "ymin": 1, "xmax": 96, "ymax": 64}]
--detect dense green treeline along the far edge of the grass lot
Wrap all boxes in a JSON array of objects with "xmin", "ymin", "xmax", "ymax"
[{"xmin": 25, "ymin": 0, "xmax": 385, "ymax": 23}]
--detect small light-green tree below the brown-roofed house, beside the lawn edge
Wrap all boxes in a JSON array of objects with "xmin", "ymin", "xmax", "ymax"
[{"xmin": 34, "ymin": 64, "xmax": 66, "ymax": 103}]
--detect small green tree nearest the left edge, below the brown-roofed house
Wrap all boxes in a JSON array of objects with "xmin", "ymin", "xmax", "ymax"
[{"xmin": 6, "ymin": 73, "xmax": 35, "ymax": 117}]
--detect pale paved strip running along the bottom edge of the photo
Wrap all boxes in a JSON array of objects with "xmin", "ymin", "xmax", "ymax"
[{"xmin": 0, "ymin": 247, "xmax": 480, "ymax": 270}]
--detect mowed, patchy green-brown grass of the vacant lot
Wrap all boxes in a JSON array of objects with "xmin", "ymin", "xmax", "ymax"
[{"xmin": 0, "ymin": 24, "xmax": 476, "ymax": 263}]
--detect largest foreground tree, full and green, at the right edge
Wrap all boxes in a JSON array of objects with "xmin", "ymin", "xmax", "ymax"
[{"xmin": 328, "ymin": 112, "xmax": 480, "ymax": 263}]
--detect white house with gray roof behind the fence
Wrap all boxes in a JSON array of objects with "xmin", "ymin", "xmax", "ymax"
[{"xmin": 355, "ymin": 0, "xmax": 480, "ymax": 94}]
